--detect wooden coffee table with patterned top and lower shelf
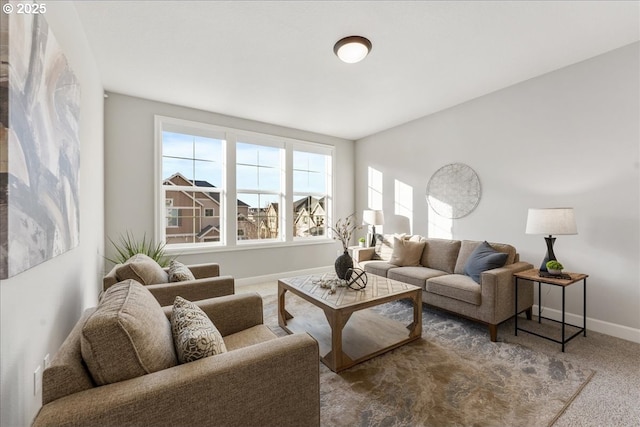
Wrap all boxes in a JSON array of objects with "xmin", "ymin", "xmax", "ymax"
[{"xmin": 278, "ymin": 273, "xmax": 422, "ymax": 372}]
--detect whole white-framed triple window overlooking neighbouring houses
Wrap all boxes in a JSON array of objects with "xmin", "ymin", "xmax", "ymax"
[{"xmin": 156, "ymin": 116, "xmax": 333, "ymax": 253}]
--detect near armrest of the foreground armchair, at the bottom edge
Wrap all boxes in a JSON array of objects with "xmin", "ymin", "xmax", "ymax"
[{"xmin": 33, "ymin": 334, "xmax": 320, "ymax": 427}]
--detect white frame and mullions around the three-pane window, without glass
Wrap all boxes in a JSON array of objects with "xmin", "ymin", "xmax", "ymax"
[{"xmin": 154, "ymin": 115, "xmax": 336, "ymax": 254}]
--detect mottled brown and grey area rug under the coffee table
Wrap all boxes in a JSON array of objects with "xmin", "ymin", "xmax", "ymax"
[{"xmin": 264, "ymin": 294, "xmax": 593, "ymax": 427}]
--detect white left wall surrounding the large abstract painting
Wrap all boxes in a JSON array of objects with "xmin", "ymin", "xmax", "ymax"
[{"xmin": 0, "ymin": 2, "xmax": 104, "ymax": 427}]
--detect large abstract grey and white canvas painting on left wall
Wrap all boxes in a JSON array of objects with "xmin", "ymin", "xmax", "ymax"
[{"xmin": 0, "ymin": 9, "xmax": 80, "ymax": 279}]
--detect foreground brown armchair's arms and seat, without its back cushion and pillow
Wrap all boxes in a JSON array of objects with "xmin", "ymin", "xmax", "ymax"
[{"xmin": 33, "ymin": 294, "xmax": 320, "ymax": 427}]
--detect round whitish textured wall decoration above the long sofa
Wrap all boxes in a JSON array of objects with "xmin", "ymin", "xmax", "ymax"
[{"xmin": 427, "ymin": 163, "xmax": 480, "ymax": 219}]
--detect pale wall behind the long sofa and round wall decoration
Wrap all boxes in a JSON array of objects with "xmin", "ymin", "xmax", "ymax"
[{"xmin": 356, "ymin": 43, "xmax": 640, "ymax": 342}]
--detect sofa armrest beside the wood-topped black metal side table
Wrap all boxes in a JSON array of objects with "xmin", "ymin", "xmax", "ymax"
[{"xmin": 480, "ymin": 261, "xmax": 533, "ymax": 324}]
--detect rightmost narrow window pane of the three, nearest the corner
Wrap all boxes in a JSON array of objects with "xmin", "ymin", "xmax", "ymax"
[{"xmin": 293, "ymin": 151, "xmax": 331, "ymax": 238}]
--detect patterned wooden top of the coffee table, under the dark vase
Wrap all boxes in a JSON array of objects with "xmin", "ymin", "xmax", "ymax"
[{"xmin": 279, "ymin": 273, "xmax": 420, "ymax": 309}]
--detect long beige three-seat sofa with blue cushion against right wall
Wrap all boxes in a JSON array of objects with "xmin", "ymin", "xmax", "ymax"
[{"xmin": 354, "ymin": 235, "xmax": 533, "ymax": 341}]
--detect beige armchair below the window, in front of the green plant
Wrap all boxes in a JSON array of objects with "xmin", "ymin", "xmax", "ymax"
[{"xmin": 102, "ymin": 255, "xmax": 235, "ymax": 306}]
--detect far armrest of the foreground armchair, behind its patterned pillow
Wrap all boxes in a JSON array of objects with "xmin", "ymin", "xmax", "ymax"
[{"xmin": 162, "ymin": 292, "xmax": 263, "ymax": 337}]
